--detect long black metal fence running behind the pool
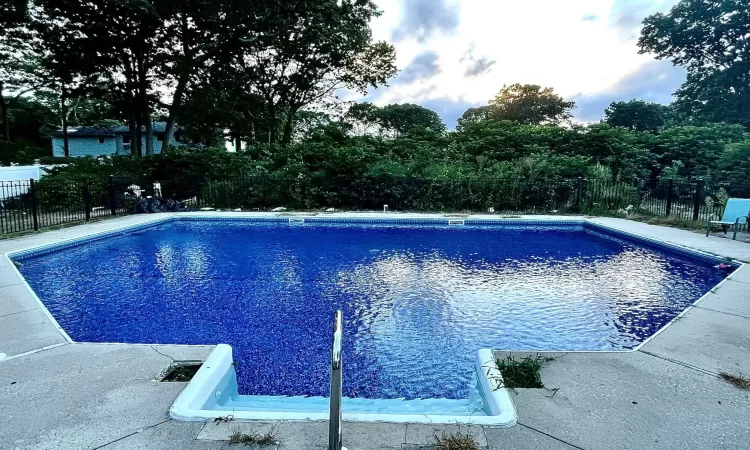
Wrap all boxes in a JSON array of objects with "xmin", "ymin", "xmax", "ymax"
[{"xmin": 0, "ymin": 176, "xmax": 750, "ymax": 234}]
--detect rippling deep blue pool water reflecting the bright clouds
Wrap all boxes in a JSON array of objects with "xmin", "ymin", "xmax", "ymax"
[{"xmin": 21, "ymin": 221, "xmax": 727, "ymax": 399}]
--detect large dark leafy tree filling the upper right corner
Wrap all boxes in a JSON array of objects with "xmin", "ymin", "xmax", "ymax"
[{"xmin": 638, "ymin": 0, "xmax": 750, "ymax": 129}]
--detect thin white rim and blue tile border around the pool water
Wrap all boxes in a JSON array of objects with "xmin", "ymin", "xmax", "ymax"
[{"xmin": 3, "ymin": 213, "xmax": 745, "ymax": 426}]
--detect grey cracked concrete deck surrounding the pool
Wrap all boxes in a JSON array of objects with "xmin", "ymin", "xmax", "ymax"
[{"xmin": 0, "ymin": 213, "xmax": 750, "ymax": 450}]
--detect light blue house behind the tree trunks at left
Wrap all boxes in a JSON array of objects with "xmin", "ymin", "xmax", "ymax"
[{"xmin": 52, "ymin": 122, "xmax": 180, "ymax": 157}]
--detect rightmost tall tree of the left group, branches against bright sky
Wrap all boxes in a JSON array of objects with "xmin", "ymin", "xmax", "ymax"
[{"xmin": 227, "ymin": 0, "xmax": 396, "ymax": 143}]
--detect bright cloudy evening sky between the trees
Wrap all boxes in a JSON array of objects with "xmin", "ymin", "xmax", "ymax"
[{"xmin": 347, "ymin": 0, "xmax": 685, "ymax": 128}]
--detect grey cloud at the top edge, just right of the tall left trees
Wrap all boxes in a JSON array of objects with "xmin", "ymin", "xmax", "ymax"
[{"xmin": 391, "ymin": 0, "xmax": 459, "ymax": 43}]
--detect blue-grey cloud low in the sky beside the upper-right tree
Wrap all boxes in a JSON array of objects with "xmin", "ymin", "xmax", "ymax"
[{"xmin": 572, "ymin": 60, "xmax": 686, "ymax": 122}]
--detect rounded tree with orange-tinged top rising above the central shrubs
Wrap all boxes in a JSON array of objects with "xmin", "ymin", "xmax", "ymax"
[{"xmin": 479, "ymin": 84, "xmax": 576, "ymax": 125}]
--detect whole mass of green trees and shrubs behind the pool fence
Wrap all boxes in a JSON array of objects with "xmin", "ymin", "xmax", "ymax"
[{"xmin": 0, "ymin": 0, "xmax": 750, "ymax": 195}]
